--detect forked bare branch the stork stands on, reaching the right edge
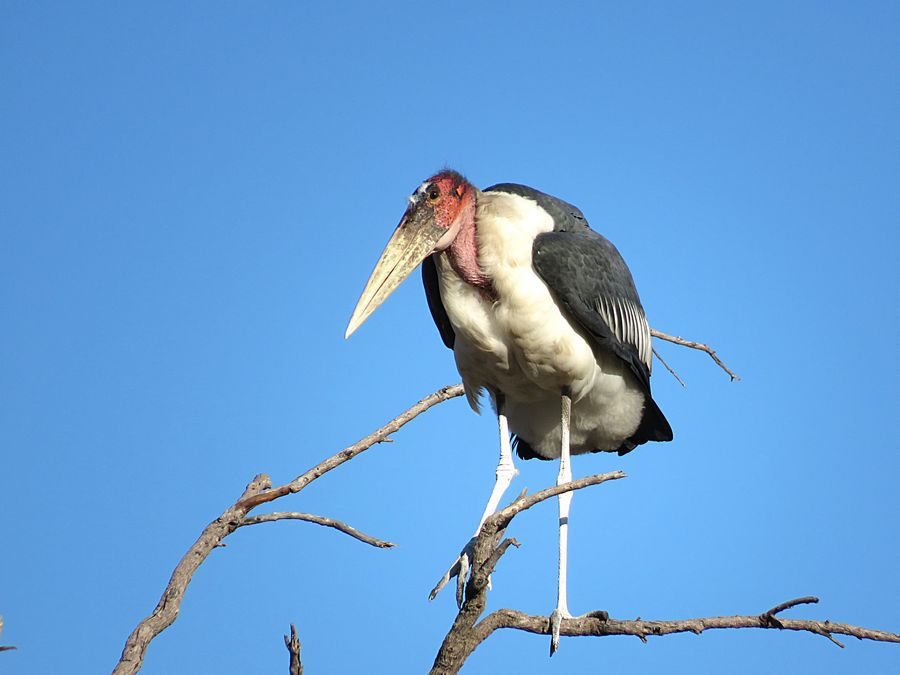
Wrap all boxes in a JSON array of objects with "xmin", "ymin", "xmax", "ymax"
[{"xmin": 431, "ymin": 472, "xmax": 900, "ymax": 675}]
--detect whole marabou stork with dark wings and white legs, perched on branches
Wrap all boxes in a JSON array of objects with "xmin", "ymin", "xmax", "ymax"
[{"xmin": 346, "ymin": 170, "xmax": 672, "ymax": 654}]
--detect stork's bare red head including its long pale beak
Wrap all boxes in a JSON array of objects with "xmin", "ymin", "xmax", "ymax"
[{"xmin": 344, "ymin": 169, "xmax": 476, "ymax": 337}]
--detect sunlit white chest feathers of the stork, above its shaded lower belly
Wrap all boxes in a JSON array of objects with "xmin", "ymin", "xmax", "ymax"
[{"xmin": 438, "ymin": 193, "xmax": 596, "ymax": 400}]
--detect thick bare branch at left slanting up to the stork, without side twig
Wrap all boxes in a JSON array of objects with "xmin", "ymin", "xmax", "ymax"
[{"xmin": 113, "ymin": 385, "xmax": 463, "ymax": 675}]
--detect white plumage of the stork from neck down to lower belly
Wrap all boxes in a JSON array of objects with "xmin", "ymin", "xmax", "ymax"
[{"xmin": 437, "ymin": 193, "xmax": 644, "ymax": 458}]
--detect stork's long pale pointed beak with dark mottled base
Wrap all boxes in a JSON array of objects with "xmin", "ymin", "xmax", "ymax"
[{"xmin": 344, "ymin": 209, "xmax": 447, "ymax": 338}]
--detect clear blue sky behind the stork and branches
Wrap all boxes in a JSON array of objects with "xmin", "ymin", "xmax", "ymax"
[{"xmin": 0, "ymin": 2, "xmax": 900, "ymax": 675}]
